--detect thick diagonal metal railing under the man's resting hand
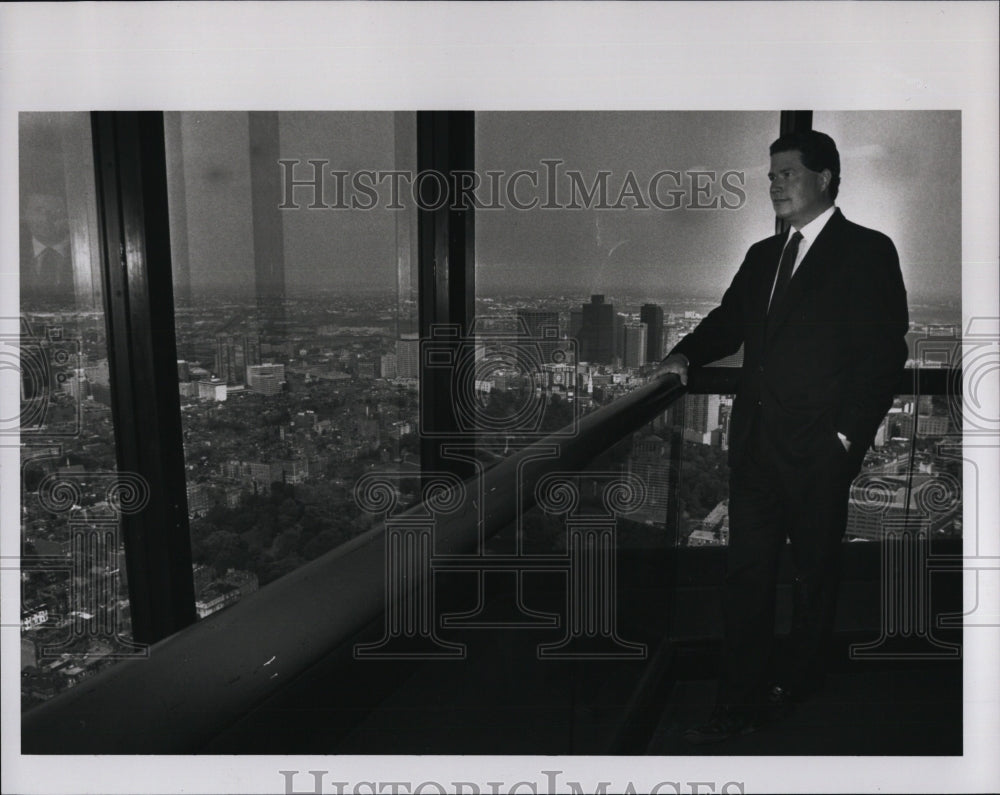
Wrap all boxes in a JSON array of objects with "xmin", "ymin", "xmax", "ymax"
[{"xmin": 21, "ymin": 376, "xmax": 685, "ymax": 754}]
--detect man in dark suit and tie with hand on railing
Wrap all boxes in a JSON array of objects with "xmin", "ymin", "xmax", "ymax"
[{"xmin": 658, "ymin": 131, "xmax": 909, "ymax": 743}]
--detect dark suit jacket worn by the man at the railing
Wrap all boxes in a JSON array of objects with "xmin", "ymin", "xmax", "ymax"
[{"xmin": 671, "ymin": 209, "xmax": 909, "ymax": 466}]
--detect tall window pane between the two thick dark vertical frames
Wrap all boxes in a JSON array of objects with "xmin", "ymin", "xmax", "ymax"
[{"xmin": 166, "ymin": 112, "xmax": 419, "ymax": 617}]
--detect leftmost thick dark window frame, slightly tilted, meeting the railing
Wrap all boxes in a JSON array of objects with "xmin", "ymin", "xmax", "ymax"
[{"xmin": 91, "ymin": 111, "xmax": 196, "ymax": 643}]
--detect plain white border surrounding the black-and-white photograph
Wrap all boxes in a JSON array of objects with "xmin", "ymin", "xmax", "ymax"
[{"xmin": 0, "ymin": 2, "xmax": 1000, "ymax": 793}]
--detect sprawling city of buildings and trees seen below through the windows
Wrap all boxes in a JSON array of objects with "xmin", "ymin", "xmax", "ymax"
[{"xmin": 21, "ymin": 290, "xmax": 961, "ymax": 708}]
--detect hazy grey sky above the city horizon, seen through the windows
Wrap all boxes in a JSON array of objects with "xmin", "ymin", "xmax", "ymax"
[{"xmin": 22, "ymin": 111, "xmax": 961, "ymax": 306}]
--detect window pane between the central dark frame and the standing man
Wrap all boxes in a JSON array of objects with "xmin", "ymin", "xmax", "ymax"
[{"xmin": 476, "ymin": 112, "xmax": 779, "ymax": 550}]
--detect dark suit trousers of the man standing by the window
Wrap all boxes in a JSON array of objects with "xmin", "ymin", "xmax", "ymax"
[{"xmin": 717, "ymin": 420, "xmax": 860, "ymax": 708}]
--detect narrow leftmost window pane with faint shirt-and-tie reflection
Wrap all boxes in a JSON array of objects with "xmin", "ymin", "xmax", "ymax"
[{"xmin": 20, "ymin": 113, "xmax": 135, "ymax": 709}]
